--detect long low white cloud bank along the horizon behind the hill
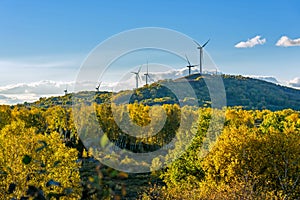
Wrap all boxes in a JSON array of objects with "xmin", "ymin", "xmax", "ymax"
[{"xmin": 0, "ymin": 68, "xmax": 215, "ymax": 105}]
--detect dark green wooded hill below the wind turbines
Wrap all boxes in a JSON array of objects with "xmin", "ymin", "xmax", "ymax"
[{"xmin": 30, "ymin": 74, "xmax": 300, "ymax": 110}]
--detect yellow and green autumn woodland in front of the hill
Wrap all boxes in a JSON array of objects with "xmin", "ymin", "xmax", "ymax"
[{"xmin": 0, "ymin": 103, "xmax": 300, "ymax": 199}]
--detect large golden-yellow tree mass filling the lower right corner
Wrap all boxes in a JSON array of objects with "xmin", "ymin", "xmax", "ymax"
[{"xmin": 202, "ymin": 110, "xmax": 300, "ymax": 199}]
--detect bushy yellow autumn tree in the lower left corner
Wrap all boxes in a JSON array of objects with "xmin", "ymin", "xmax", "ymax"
[{"xmin": 0, "ymin": 120, "xmax": 81, "ymax": 199}]
